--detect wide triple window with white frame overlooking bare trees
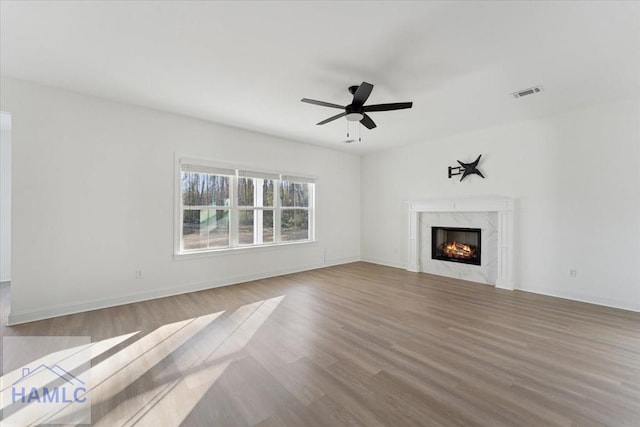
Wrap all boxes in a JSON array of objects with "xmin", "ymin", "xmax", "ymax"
[{"xmin": 176, "ymin": 159, "xmax": 315, "ymax": 253}]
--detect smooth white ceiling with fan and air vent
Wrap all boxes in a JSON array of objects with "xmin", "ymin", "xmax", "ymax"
[{"xmin": 0, "ymin": 0, "xmax": 640, "ymax": 154}]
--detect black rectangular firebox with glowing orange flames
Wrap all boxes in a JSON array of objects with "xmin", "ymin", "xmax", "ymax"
[{"xmin": 431, "ymin": 227, "xmax": 482, "ymax": 265}]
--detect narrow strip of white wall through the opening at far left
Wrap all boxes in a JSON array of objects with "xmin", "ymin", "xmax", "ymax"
[{"xmin": 0, "ymin": 113, "xmax": 11, "ymax": 282}]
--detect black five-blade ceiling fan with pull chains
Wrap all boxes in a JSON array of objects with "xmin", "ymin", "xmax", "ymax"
[{"xmin": 301, "ymin": 82, "xmax": 413, "ymax": 129}]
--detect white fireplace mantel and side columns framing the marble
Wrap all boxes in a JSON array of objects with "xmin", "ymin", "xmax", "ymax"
[{"xmin": 407, "ymin": 197, "xmax": 514, "ymax": 289}]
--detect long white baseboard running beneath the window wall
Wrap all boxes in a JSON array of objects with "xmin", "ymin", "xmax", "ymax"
[{"xmin": 7, "ymin": 257, "xmax": 360, "ymax": 326}]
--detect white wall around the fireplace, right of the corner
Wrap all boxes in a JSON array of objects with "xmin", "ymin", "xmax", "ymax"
[{"xmin": 362, "ymin": 99, "xmax": 640, "ymax": 311}]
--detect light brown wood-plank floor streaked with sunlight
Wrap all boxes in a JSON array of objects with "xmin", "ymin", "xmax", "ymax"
[{"xmin": 2, "ymin": 262, "xmax": 640, "ymax": 427}]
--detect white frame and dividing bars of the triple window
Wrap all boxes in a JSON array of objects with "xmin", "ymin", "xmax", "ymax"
[{"xmin": 173, "ymin": 155, "xmax": 317, "ymax": 257}]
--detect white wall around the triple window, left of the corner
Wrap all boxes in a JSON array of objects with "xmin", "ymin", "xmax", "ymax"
[{"xmin": 1, "ymin": 79, "xmax": 360, "ymax": 323}]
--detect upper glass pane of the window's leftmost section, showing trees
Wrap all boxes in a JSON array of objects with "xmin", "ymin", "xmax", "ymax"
[{"xmin": 182, "ymin": 171, "xmax": 229, "ymax": 206}]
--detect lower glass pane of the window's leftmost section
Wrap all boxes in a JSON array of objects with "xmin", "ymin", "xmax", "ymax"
[{"xmin": 182, "ymin": 209, "xmax": 229, "ymax": 250}]
